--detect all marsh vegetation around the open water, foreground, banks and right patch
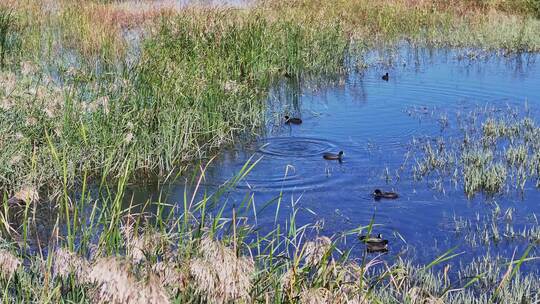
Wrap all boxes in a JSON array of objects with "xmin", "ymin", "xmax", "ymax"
[{"xmin": 0, "ymin": 0, "xmax": 540, "ymax": 303}]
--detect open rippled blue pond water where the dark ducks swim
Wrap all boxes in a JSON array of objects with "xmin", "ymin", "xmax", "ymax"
[{"xmin": 127, "ymin": 47, "xmax": 540, "ymax": 269}]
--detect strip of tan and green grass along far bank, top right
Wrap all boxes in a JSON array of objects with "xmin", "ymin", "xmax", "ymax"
[{"xmin": 264, "ymin": 0, "xmax": 540, "ymax": 52}]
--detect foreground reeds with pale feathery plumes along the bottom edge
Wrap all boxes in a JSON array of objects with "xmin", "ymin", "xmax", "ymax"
[{"xmin": 0, "ymin": 162, "xmax": 540, "ymax": 303}]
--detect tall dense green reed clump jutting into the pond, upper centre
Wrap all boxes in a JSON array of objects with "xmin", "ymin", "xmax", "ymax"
[{"xmin": 132, "ymin": 10, "xmax": 348, "ymax": 168}]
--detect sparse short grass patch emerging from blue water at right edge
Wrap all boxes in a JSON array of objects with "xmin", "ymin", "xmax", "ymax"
[{"xmin": 411, "ymin": 108, "xmax": 540, "ymax": 197}]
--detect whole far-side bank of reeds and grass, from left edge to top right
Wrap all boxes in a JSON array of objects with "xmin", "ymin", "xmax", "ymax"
[{"xmin": 0, "ymin": 0, "xmax": 539, "ymax": 194}]
